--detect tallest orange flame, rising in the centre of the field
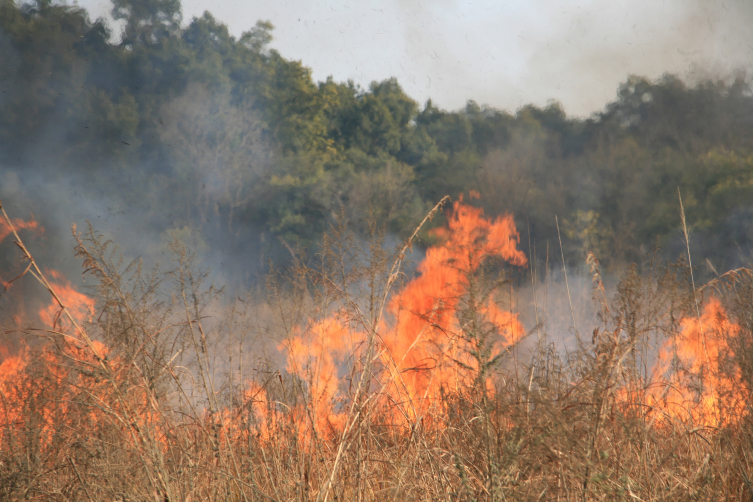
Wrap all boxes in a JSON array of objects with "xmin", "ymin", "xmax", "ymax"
[{"xmin": 384, "ymin": 199, "xmax": 527, "ymax": 413}]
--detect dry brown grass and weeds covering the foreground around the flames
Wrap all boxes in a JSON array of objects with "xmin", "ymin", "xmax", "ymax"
[{"xmin": 0, "ymin": 200, "xmax": 753, "ymax": 501}]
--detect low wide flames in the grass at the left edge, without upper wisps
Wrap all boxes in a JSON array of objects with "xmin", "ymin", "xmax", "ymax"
[{"xmin": 0, "ymin": 339, "xmax": 167, "ymax": 455}]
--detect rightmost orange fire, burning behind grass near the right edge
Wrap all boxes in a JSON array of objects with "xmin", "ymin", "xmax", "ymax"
[{"xmin": 648, "ymin": 297, "xmax": 745, "ymax": 426}]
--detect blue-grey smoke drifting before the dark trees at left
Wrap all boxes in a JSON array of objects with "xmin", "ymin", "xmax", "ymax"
[{"xmin": 0, "ymin": 79, "xmax": 275, "ymax": 308}]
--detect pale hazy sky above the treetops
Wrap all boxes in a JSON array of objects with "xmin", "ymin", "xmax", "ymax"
[{"xmin": 73, "ymin": 0, "xmax": 753, "ymax": 116}]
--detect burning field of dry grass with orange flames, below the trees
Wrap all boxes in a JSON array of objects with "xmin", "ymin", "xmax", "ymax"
[{"xmin": 0, "ymin": 198, "xmax": 753, "ymax": 501}]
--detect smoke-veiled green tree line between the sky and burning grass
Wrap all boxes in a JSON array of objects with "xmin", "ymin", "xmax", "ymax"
[{"xmin": 0, "ymin": 0, "xmax": 753, "ymax": 273}]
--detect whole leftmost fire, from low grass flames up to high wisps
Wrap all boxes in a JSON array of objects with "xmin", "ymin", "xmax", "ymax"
[{"xmin": 0, "ymin": 211, "xmax": 170, "ymax": 455}]
